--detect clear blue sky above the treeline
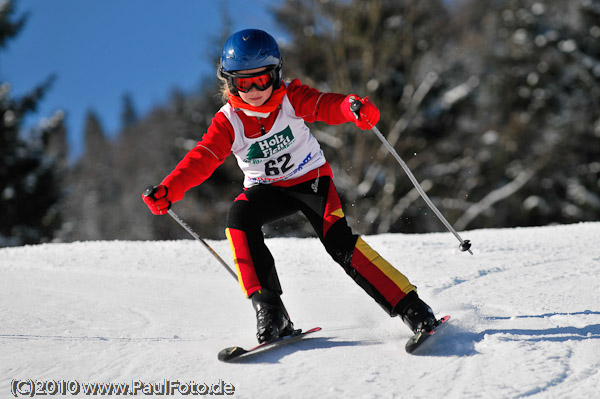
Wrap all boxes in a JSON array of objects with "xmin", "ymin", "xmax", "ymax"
[{"xmin": 0, "ymin": 0, "xmax": 278, "ymax": 156}]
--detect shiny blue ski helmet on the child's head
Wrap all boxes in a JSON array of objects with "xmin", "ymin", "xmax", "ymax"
[{"xmin": 220, "ymin": 29, "xmax": 281, "ymax": 72}]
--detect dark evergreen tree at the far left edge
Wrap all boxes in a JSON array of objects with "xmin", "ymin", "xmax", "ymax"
[{"xmin": 0, "ymin": 0, "xmax": 65, "ymax": 246}]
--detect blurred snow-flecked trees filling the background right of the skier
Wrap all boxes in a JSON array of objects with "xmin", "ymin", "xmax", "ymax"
[{"xmin": 276, "ymin": 0, "xmax": 600, "ymax": 233}]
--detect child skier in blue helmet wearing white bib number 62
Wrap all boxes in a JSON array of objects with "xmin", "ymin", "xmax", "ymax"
[{"xmin": 143, "ymin": 29, "xmax": 436, "ymax": 343}]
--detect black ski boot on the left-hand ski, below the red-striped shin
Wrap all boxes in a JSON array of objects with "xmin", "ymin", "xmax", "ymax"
[{"xmin": 250, "ymin": 290, "xmax": 294, "ymax": 344}]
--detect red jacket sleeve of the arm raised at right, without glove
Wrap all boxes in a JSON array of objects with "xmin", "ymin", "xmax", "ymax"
[{"xmin": 287, "ymin": 79, "xmax": 350, "ymax": 125}]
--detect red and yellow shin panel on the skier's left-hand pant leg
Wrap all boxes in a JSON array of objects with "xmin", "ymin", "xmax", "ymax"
[{"xmin": 225, "ymin": 228, "xmax": 262, "ymax": 297}]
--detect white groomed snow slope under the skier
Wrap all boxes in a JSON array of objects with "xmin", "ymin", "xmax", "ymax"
[{"xmin": 0, "ymin": 222, "xmax": 600, "ymax": 398}]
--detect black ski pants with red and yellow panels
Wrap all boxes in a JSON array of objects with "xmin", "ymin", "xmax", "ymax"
[{"xmin": 226, "ymin": 176, "xmax": 416, "ymax": 316}]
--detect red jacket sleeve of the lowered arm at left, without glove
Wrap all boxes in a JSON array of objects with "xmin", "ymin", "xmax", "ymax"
[{"xmin": 161, "ymin": 112, "xmax": 234, "ymax": 202}]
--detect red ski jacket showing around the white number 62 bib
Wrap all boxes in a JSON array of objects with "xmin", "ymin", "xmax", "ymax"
[{"xmin": 161, "ymin": 79, "xmax": 349, "ymax": 202}]
